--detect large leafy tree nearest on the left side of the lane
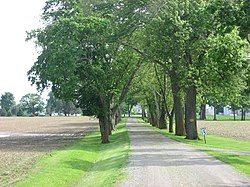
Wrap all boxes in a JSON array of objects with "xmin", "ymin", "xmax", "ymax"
[{"xmin": 29, "ymin": 0, "xmax": 141, "ymax": 143}]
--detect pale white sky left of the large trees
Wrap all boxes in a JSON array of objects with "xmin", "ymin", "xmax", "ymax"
[{"xmin": 0, "ymin": 0, "xmax": 48, "ymax": 102}]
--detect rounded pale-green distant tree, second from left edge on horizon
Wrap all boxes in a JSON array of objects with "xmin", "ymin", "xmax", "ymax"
[{"xmin": 20, "ymin": 94, "xmax": 44, "ymax": 116}]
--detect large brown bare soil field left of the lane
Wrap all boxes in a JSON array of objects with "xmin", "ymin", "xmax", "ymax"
[{"xmin": 0, "ymin": 117, "xmax": 98, "ymax": 186}]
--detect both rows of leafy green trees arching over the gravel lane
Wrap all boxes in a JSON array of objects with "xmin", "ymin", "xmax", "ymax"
[{"xmin": 28, "ymin": 0, "xmax": 249, "ymax": 143}]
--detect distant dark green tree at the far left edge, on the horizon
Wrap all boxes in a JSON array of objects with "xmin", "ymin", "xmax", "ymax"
[{"xmin": 0, "ymin": 92, "xmax": 16, "ymax": 116}]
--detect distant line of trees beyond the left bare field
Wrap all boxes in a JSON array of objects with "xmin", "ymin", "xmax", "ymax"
[{"xmin": 0, "ymin": 92, "xmax": 81, "ymax": 116}]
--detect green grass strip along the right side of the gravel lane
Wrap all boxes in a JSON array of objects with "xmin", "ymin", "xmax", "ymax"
[{"xmin": 138, "ymin": 119, "xmax": 250, "ymax": 176}]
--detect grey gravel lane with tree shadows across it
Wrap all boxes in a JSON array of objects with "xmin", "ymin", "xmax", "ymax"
[{"xmin": 118, "ymin": 119, "xmax": 250, "ymax": 187}]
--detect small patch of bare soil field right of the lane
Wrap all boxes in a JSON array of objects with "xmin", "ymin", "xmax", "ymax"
[{"xmin": 198, "ymin": 121, "xmax": 250, "ymax": 140}]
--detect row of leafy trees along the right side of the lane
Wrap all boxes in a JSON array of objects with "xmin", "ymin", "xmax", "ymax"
[{"xmin": 123, "ymin": 0, "xmax": 250, "ymax": 139}]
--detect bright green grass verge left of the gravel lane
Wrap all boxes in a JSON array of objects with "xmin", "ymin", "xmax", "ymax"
[{"xmin": 16, "ymin": 122, "xmax": 130, "ymax": 187}]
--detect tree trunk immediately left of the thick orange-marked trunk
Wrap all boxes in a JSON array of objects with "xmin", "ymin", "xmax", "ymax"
[{"xmin": 170, "ymin": 74, "xmax": 186, "ymax": 136}]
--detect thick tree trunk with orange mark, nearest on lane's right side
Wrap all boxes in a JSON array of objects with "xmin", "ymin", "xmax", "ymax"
[{"xmin": 185, "ymin": 85, "xmax": 198, "ymax": 140}]
